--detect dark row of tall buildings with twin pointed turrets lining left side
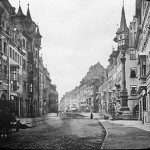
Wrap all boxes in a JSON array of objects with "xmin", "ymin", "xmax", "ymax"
[{"xmin": 0, "ymin": 0, "xmax": 58, "ymax": 117}]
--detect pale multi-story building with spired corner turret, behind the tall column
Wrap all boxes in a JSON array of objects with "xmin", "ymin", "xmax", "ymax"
[{"xmin": 99, "ymin": 3, "xmax": 138, "ymax": 117}]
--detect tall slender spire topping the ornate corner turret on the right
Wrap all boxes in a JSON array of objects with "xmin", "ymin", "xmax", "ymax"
[{"xmin": 120, "ymin": 1, "xmax": 128, "ymax": 32}]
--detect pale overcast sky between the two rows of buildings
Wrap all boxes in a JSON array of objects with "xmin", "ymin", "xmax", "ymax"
[{"xmin": 9, "ymin": 0, "xmax": 135, "ymax": 100}]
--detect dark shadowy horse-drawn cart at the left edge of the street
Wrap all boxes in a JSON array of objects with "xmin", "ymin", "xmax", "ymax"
[{"xmin": 0, "ymin": 99, "xmax": 15, "ymax": 138}]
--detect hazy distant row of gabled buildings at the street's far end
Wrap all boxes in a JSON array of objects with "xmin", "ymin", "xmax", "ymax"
[{"xmin": 59, "ymin": 62, "xmax": 105, "ymax": 112}]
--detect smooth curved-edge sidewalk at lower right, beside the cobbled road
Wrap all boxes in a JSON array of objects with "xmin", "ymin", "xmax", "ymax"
[{"xmin": 94, "ymin": 114, "xmax": 150, "ymax": 149}]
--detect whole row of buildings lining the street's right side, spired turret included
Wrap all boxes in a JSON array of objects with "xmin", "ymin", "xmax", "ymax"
[{"xmin": 59, "ymin": 0, "xmax": 150, "ymax": 123}]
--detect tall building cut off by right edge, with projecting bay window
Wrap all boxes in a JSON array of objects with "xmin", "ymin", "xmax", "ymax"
[{"xmin": 135, "ymin": 0, "xmax": 150, "ymax": 123}]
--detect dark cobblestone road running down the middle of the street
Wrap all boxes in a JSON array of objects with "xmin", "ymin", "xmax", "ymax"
[{"xmin": 0, "ymin": 114, "xmax": 105, "ymax": 150}]
